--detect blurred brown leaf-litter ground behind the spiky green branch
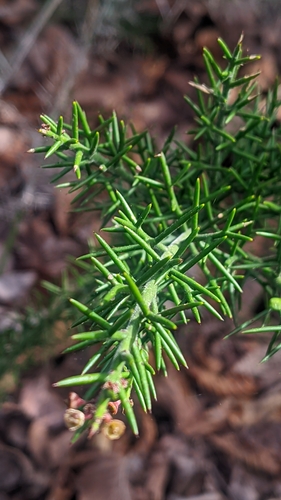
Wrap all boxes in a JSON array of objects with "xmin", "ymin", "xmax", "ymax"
[{"xmin": 0, "ymin": 0, "xmax": 281, "ymax": 500}]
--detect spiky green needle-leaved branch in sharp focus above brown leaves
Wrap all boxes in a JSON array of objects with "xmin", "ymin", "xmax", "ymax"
[{"xmin": 32, "ymin": 38, "xmax": 281, "ymax": 437}]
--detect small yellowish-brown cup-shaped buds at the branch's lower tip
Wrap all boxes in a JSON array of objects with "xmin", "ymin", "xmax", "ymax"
[{"xmin": 64, "ymin": 392, "xmax": 126, "ymax": 440}]
